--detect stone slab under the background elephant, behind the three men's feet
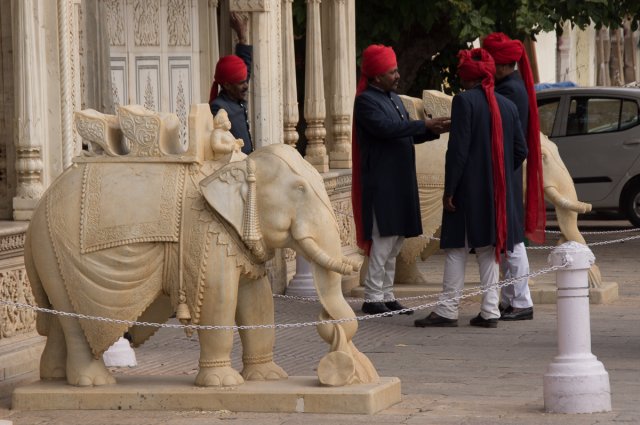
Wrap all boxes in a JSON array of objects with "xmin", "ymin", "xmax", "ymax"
[{"xmin": 351, "ymin": 282, "xmax": 618, "ymax": 305}]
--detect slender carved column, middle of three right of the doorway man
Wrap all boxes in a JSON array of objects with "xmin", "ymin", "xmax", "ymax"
[{"xmin": 304, "ymin": 0, "xmax": 329, "ymax": 173}]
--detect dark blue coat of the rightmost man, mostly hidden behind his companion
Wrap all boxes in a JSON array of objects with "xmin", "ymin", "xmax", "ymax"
[{"xmin": 496, "ymin": 72, "xmax": 529, "ymax": 243}]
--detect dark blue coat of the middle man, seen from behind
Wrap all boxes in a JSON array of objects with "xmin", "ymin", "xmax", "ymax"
[{"xmin": 440, "ymin": 86, "xmax": 527, "ymax": 250}]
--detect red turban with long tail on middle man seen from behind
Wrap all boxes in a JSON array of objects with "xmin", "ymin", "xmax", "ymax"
[{"xmin": 458, "ymin": 49, "xmax": 507, "ymax": 262}]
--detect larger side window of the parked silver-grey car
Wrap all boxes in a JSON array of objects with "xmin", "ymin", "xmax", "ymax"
[{"xmin": 567, "ymin": 96, "xmax": 638, "ymax": 136}]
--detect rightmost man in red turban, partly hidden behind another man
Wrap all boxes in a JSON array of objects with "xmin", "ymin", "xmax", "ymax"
[{"xmin": 482, "ymin": 33, "xmax": 546, "ymax": 320}]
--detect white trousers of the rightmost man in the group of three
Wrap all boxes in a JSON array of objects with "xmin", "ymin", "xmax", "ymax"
[{"xmin": 501, "ymin": 242, "xmax": 533, "ymax": 308}]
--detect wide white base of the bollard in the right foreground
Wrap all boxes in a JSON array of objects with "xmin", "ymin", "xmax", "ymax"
[{"xmin": 543, "ymin": 356, "xmax": 611, "ymax": 413}]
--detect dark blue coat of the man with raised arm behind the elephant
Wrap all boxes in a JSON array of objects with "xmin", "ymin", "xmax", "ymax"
[{"xmin": 209, "ymin": 44, "xmax": 253, "ymax": 155}]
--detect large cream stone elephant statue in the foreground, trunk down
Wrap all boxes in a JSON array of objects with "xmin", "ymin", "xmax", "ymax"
[{"xmin": 25, "ymin": 105, "xmax": 378, "ymax": 387}]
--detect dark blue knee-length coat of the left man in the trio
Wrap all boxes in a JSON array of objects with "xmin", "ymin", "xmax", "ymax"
[{"xmin": 353, "ymin": 86, "xmax": 439, "ymax": 240}]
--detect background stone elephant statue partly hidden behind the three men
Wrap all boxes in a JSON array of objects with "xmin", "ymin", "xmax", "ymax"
[{"xmin": 384, "ymin": 90, "xmax": 602, "ymax": 287}]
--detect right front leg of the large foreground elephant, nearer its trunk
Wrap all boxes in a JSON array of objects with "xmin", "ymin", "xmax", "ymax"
[{"xmin": 236, "ymin": 276, "xmax": 287, "ymax": 381}]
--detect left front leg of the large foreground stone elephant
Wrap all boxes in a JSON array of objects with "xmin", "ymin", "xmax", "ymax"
[{"xmin": 195, "ymin": 249, "xmax": 244, "ymax": 387}]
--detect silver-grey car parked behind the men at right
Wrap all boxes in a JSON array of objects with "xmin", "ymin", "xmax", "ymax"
[{"xmin": 537, "ymin": 87, "xmax": 640, "ymax": 227}]
